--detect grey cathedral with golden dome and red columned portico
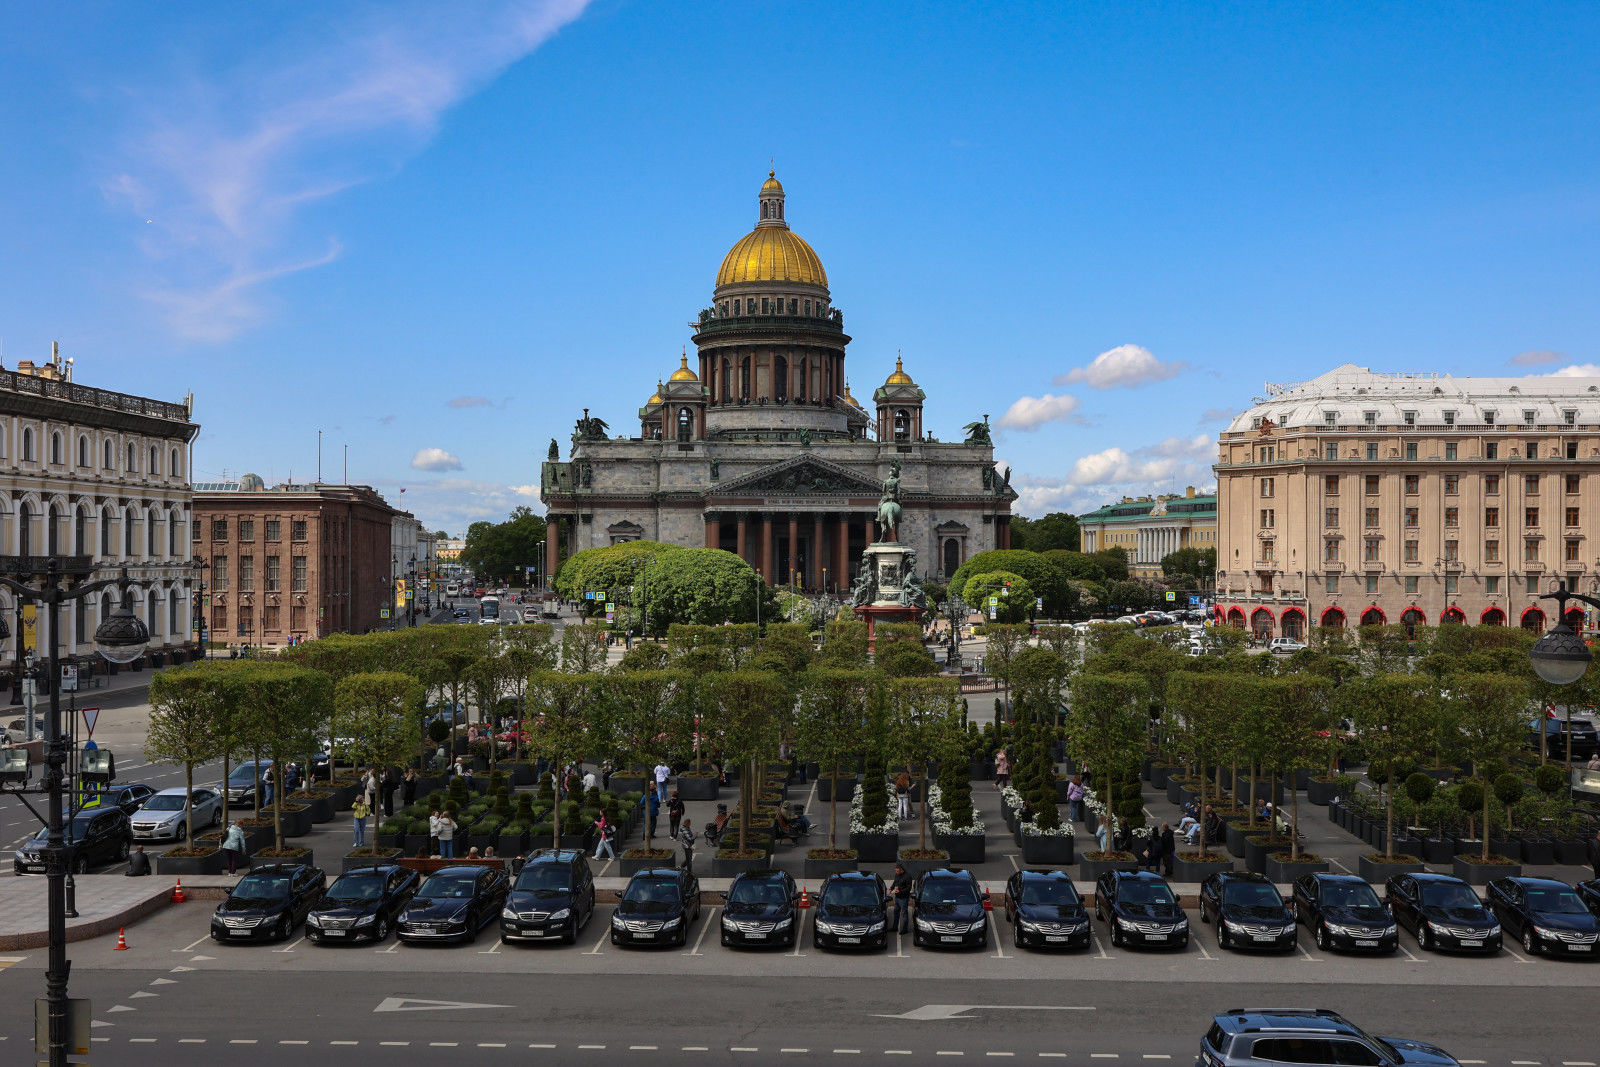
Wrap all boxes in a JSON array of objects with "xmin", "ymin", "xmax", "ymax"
[{"xmin": 541, "ymin": 171, "xmax": 1016, "ymax": 592}]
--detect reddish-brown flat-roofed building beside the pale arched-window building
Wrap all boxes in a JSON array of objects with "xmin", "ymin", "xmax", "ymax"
[{"xmin": 194, "ymin": 474, "xmax": 402, "ymax": 646}]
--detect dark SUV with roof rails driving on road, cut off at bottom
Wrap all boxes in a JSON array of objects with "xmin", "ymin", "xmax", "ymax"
[{"xmin": 1195, "ymin": 1008, "xmax": 1458, "ymax": 1067}]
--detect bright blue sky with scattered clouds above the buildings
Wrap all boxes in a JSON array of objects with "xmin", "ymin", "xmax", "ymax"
[{"xmin": 0, "ymin": 0, "xmax": 1600, "ymax": 533}]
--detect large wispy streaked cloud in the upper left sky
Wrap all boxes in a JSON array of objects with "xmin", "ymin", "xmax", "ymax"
[{"xmin": 102, "ymin": 0, "xmax": 589, "ymax": 341}]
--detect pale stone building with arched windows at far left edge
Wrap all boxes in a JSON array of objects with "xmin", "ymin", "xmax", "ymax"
[{"xmin": 0, "ymin": 352, "xmax": 200, "ymax": 691}]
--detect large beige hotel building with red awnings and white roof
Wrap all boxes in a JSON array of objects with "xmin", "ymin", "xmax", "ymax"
[{"xmin": 1216, "ymin": 365, "xmax": 1600, "ymax": 637}]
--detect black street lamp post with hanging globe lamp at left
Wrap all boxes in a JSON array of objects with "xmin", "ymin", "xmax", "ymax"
[{"xmin": 0, "ymin": 555, "xmax": 150, "ymax": 1067}]
